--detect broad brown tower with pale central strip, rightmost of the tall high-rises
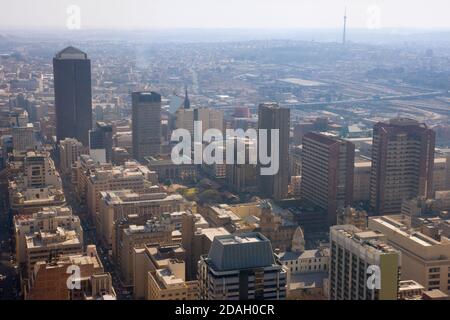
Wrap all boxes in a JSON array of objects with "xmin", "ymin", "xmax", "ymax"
[{"xmin": 370, "ymin": 118, "xmax": 436, "ymax": 215}]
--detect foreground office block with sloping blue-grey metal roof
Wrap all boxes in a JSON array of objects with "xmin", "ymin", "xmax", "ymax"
[{"xmin": 198, "ymin": 232, "xmax": 287, "ymax": 300}]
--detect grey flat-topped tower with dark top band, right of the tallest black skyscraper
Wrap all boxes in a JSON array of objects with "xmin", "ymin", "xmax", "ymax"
[{"xmin": 132, "ymin": 92, "xmax": 161, "ymax": 163}]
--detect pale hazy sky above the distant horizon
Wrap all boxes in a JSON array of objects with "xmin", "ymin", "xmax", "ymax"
[{"xmin": 0, "ymin": 0, "xmax": 450, "ymax": 29}]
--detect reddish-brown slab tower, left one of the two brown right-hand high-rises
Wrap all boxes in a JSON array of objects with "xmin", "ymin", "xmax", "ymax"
[{"xmin": 301, "ymin": 132, "xmax": 355, "ymax": 225}]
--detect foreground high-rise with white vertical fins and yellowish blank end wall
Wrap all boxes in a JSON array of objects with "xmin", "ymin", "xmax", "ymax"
[{"xmin": 330, "ymin": 225, "xmax": 401, "ymax": 300}]
